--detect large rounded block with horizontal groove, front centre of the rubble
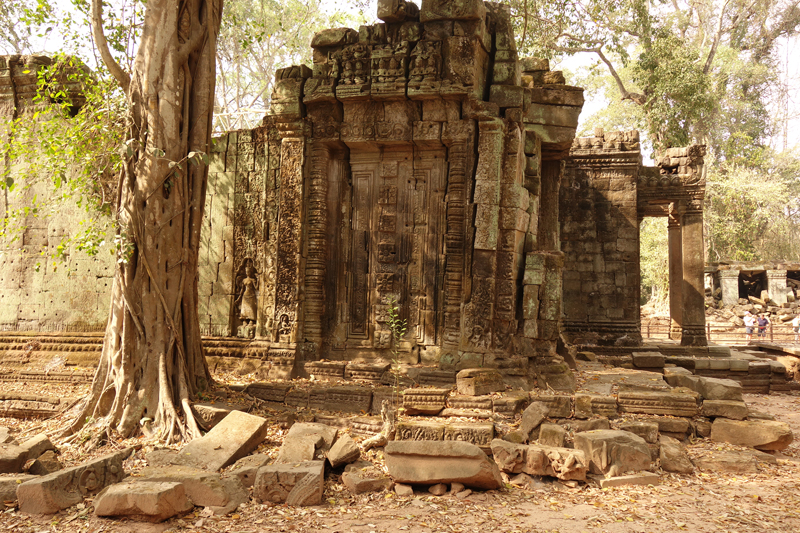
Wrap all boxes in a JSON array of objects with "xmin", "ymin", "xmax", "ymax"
[{"xmin": 384, "ymin": 441, "xmax": 502, "ymax": 489}]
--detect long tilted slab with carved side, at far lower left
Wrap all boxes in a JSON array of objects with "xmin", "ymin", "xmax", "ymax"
[{"xmin": 17, "ymin": 448, "xmax": 133, "ymax": 514}]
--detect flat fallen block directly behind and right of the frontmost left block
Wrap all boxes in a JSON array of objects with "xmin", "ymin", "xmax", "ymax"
[{"xmin": 140, "ymin": 465, "xmax": 248, "ymax": 515}]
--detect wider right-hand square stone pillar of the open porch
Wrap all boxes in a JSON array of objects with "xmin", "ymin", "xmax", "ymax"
[{"xmin": 681, "ymin": 200, "xmax": 708, "ymax": 346}]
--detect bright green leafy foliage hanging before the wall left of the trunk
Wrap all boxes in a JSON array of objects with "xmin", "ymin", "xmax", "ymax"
[{"xmin": 0, "ymin": 55, "xmax": 126, "ymax": 259}]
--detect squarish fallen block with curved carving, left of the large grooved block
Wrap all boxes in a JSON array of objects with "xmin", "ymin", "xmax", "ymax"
[{"xmin": 253, "ymin": 461, "xmax": 325, "ymax": 505}]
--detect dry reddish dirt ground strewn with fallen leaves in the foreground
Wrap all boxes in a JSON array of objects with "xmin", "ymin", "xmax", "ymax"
[{"xmin": 0, "ymin": 370, "xmax": 800, "ymax": 533}]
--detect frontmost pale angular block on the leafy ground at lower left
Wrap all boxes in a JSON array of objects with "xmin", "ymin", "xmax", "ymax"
[{"xmin": 94, "ymin": 480, "xmax": 194, "ymax": 522}]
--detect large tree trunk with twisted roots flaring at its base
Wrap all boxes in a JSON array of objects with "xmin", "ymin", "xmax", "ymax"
[{"xmin": 63, "ymin": 0, "xmax": 223, "ymax": 441}]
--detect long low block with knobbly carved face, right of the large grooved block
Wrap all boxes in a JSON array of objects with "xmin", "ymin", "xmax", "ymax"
[{"xmin": 492, "ymin": 439, "xmax": 589, "ymax": 481}]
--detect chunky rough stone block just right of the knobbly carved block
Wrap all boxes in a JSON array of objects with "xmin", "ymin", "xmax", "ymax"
[{"xmin": 574, "ymin": 429, "xmax": 650, "ymax": 477}]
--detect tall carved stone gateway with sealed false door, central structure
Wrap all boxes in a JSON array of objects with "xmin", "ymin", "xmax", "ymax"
[{"xmin": 200, "ymin": 0, "xmax": 583, "ymax": 387}]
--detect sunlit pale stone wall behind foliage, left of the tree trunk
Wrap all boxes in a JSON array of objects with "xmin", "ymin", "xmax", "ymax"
[{"xmin": 0, "ymin": 55, "xmax": 114, "ymax": 331}]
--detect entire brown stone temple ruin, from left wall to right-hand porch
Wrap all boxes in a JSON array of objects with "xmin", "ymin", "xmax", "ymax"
[{"xmin": 0, "ymin": 0, "xmax": 706, "ymax": 389}]
